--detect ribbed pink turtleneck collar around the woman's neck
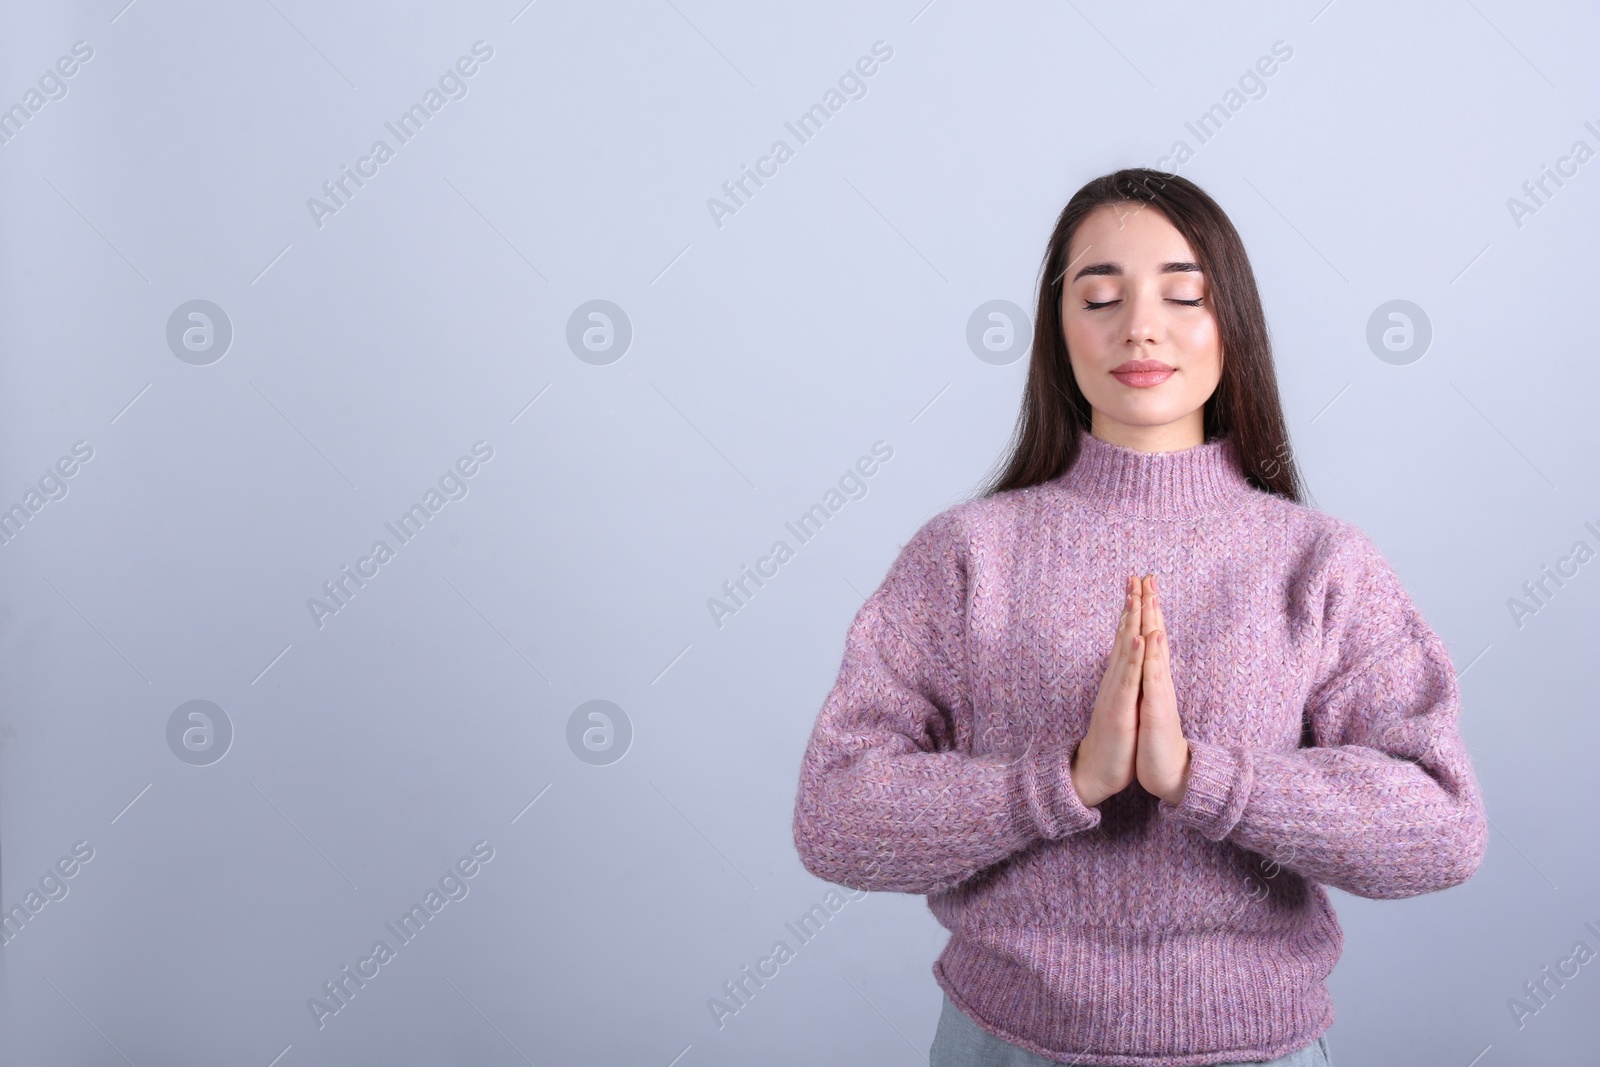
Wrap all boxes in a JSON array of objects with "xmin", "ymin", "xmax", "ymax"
[{"xmin": 1053, "ymin": 432, "xmax": 1259, "ymax": 518}]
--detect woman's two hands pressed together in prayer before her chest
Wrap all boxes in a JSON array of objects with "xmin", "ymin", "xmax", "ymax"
[{"xmin": 1070, "ymin": 574, "xmax": 1189, "ymax": 806}]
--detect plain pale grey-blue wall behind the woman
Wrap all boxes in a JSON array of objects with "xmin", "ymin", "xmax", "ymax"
[{"xmin": 0, "ymin": 0, "xmax": 1600, "ymax": 1067}]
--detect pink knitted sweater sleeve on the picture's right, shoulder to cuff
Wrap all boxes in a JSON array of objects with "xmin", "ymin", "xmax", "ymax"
[{"xmin": 1158, "ymin": 522, "xmax": 1488, "ymax": 899}]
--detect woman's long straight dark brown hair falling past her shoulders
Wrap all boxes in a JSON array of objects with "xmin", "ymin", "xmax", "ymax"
[{"xmin": 981, "ymin": 166, "xmax": 1302, "ymax": 504}]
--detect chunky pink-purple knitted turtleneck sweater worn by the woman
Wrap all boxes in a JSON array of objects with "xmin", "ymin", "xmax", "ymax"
[{"xmin": 794, "ymin": 435, "xmax": 1488, "ymax": 1067}]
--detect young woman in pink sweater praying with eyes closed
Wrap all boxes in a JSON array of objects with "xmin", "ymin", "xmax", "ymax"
[{"xmin": 794, "ymin": 170, "xmax": 1488, "ymax": 1067}]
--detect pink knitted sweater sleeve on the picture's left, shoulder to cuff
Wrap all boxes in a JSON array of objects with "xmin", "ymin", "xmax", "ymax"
[{"xmin": 794, "ymin": 509, "xmax": 1101, "ymax": 893}]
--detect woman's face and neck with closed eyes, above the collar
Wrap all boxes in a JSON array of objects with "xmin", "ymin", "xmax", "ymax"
[{"xmin": 1061, "ymin": 203, "xmax": 1222, "ymax": 451}]
